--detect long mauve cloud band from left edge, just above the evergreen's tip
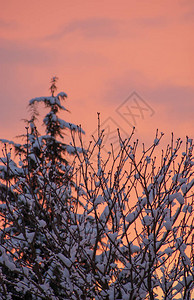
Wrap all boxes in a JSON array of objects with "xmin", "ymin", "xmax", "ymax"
[{"xmin": 0, "ymin": 39, "xmax": 108, "ymax": 68}]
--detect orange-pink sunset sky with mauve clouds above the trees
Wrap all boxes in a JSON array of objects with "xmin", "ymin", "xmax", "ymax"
[{"xmin": 0, "ymin": 0, "xmax": 194, "ymax": 152}]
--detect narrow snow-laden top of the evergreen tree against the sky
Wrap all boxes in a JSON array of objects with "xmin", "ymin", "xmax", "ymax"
[{"xmin": 29, "ymin": 77, "xmax": 83, "ymax": 165}]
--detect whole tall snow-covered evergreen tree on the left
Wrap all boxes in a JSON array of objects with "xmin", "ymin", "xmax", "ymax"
[{"xmin": 0, "ymin": 77, "xmax": 84, "ymax": 299}]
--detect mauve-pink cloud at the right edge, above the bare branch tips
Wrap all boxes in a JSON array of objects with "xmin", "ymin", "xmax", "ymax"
[{"xmin": 104, "ymin": 70, "xmax": 194, "ymax": 114}]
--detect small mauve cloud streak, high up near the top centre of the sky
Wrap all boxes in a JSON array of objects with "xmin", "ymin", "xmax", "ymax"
[{"xmin": 47, "ymin": 18, "xmax": 121, "ymax": 40}]
